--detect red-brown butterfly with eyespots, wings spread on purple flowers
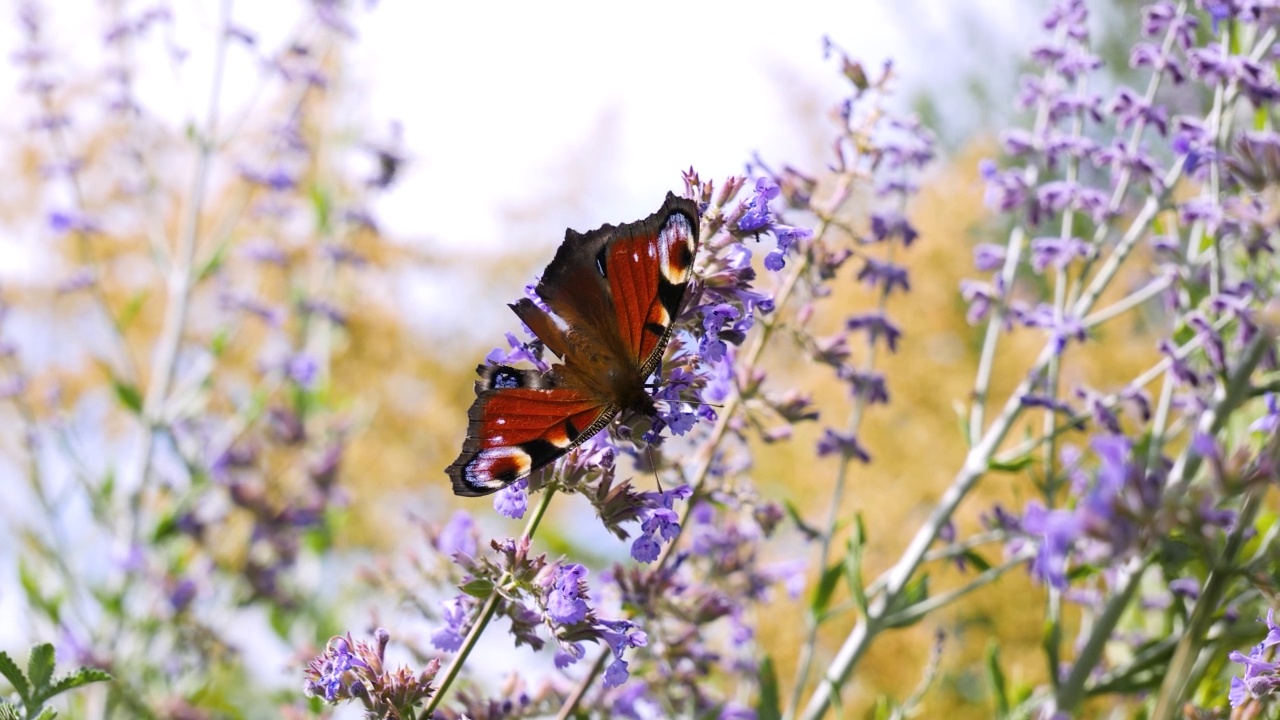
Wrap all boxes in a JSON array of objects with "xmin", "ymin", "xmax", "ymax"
[{"xmin": 445, "ymin": 192, "xmax": 698, "ymax": 497}]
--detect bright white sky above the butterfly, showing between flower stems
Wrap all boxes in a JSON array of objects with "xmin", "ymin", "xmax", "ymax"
[{"xmin": 0, "ymin": 0, "xmax": 1044, "ymax": 338}]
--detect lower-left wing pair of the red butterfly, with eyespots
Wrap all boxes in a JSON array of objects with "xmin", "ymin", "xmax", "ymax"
[{"xmin": 447, "ymin": 365, "xmax": 617, "ymax": 497}]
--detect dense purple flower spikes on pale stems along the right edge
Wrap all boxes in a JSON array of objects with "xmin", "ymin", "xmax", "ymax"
[{"xmin": 961, "ymin": 0, "xmax": 1280, "ymax": 717}]
